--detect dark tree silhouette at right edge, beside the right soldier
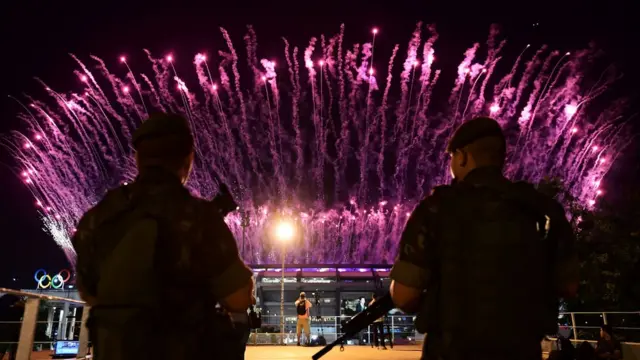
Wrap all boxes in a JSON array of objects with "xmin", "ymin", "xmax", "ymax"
[{"xmin": 538, "ymin": 178, "xmax": 640, "ymax": 311}]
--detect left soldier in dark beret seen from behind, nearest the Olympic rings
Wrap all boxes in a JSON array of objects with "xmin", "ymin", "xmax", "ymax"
[{"xmin": 73, "ymin": 114, "xmax": 255, "ymax": 360}]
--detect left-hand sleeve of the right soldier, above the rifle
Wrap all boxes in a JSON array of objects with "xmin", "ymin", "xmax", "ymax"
[{"xmin": 390, "ymin": 198, "xmax": 433, "ymax": 289}]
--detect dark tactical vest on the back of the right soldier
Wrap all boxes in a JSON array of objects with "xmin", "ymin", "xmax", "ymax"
[{"xmin": 417, "ymin": 182, "xmax": 558, "ymax": 341}]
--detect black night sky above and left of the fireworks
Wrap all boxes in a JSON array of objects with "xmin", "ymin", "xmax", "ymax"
[{"xmin": 0, "ymin": 0, "xmax": 640, "ymax": 287}]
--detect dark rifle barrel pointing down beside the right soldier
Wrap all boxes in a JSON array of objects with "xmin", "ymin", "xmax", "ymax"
[{"xmin": 311, "ymin": 293, "xmax": 395, "ymax": 360}]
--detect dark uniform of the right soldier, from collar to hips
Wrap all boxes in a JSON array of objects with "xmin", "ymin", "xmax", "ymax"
[{"xmin": 391, "ymin": 118, "xmax": 577, "ymax": 360}]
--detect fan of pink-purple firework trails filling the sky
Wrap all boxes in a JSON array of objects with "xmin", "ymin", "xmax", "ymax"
[{"xmin": 2, "ymin": 24, "xmax": 631, "ymax": 264}]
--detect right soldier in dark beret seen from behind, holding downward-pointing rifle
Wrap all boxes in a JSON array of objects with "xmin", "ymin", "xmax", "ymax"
[{"xmin": 391, "ymin": 117, "xmax": 577, "ymax": 360}]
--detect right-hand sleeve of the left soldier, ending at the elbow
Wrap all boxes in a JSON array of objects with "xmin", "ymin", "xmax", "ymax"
[{"xmin": 193, "ymin": 204, "xmax": 253, "ymax": 299}]
